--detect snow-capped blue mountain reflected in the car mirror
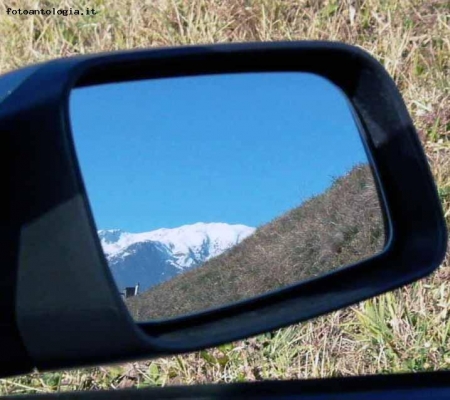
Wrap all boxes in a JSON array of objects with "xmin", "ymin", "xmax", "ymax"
[{"xmin": 98, "ymin": 222, "xmax": 255, "ymax": 291}]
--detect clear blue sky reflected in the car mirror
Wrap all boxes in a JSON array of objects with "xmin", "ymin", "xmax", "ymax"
[{"xmin": 70, "ymin": 73, "xmax": 367, "ymax": 232}]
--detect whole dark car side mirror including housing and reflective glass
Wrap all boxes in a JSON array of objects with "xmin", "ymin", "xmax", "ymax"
[{"xmin": 0, "ymin": 42, "xmax": 447, "ymax": 375}]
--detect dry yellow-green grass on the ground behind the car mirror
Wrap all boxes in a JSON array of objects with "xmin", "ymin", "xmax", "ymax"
[{"xmin": 0, "ymin": 0, "xmax": 450, "ymax": 394}]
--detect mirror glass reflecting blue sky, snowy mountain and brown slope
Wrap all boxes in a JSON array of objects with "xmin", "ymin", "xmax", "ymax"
[{"xmin": 70, "ymin": 73, "xmax": 385, "ymax": 321}]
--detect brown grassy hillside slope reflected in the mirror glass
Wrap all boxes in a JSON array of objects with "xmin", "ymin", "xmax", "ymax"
[{"xmin": 127, "ymin": 165, "xmax": 384, "ymax": 321}]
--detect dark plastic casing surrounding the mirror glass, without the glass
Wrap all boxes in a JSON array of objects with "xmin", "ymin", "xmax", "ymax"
[{"xmin": 0, "ymin": 42, "xmax": 447, "ymax": 375}]
